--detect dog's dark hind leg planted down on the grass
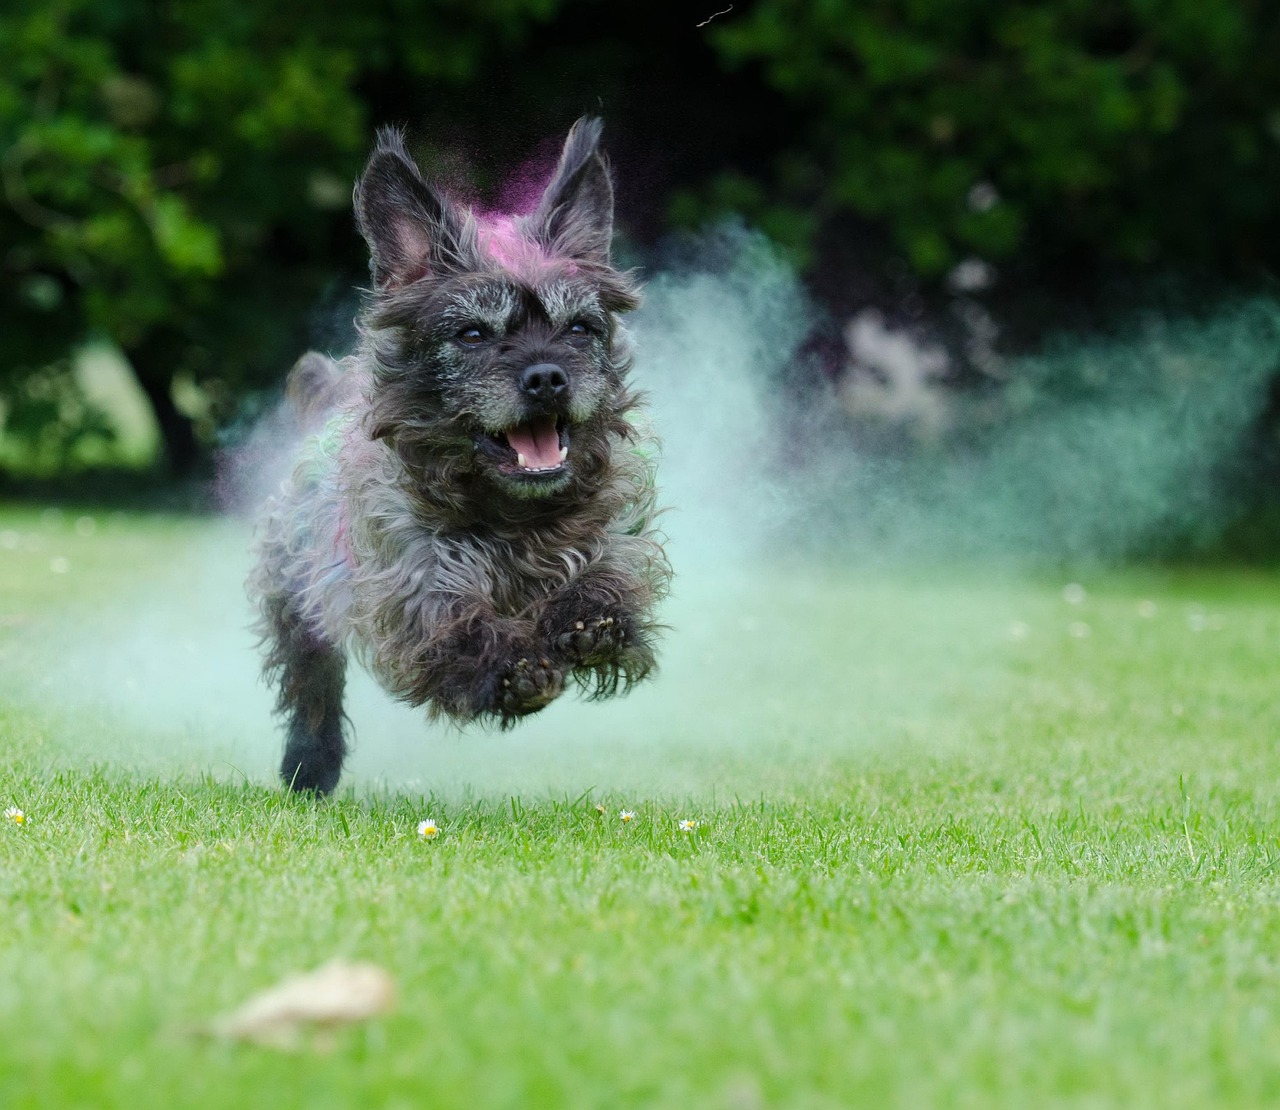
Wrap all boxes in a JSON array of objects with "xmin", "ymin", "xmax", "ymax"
[{"xmin": 262, "ymin": 597, "xmax": 347, "ymax": 794}]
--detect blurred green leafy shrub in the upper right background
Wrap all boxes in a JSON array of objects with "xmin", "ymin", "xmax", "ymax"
[{"xmin": 706, "ymin": 0, "xmax": 1280, "ymax": 277}]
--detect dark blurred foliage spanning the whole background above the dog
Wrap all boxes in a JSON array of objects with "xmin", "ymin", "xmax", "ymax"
[{"xmin": 0, "ymin": 0, "xmax": 1280, "ymax": 486}]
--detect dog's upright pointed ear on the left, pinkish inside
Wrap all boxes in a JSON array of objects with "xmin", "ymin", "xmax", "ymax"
[{"xmin": 355, "ymin": 127, "xmax": 462, "ymax": 291}]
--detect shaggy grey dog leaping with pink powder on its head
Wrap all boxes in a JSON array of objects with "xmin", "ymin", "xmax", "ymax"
[{"xmin": 250, "ymin": 119, "xmax": 671, "ymax": 792}]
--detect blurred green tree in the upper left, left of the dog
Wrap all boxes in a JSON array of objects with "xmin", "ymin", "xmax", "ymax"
[{"xmin": 0, "ymin": 0, "xmax": 556, "ymax": 475}]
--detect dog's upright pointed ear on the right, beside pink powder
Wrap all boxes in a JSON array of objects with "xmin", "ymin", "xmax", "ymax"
[{"xmin": 531, "ymin": 115, "xmax": 613, "ymax": 264}]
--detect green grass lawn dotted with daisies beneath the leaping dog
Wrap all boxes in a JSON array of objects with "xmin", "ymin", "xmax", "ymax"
[{"xmin": 0, "ymin": 510, "xmax": 1280, "ymax": 1107}]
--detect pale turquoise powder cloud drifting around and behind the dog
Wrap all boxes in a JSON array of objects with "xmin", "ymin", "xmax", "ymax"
[{"xmin": 6, "ymin": 230, "xmax": 1280, "ymax": 798}]
